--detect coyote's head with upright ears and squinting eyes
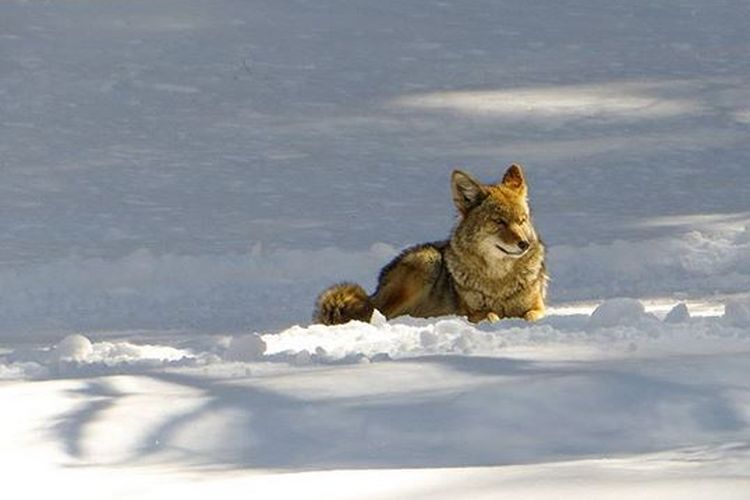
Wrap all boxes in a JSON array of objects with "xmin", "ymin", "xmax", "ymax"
[{"xmin": 451, "ymin": 164, "xmax": 538, "ymax": 263}]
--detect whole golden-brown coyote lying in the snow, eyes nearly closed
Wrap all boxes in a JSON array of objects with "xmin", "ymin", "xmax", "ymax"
[{"xmin": 314, "ymin": 165, "xmax": 548, "ymax": 325}]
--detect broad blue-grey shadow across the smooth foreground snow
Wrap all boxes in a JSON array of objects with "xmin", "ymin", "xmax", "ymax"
[{"xmin": 51, "ymin": 356, "xmax": 748, "ymax": 470}]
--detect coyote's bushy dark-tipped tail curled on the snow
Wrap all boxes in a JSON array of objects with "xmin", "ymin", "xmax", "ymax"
[{"xmin": 313, "ymin": 283, "xmax": 375, "ymax": 325}]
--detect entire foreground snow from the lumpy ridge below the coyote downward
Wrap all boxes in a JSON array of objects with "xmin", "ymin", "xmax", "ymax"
[{"xmin": 0, "ymin": 299, "xmax": 750, "ymax": 499}]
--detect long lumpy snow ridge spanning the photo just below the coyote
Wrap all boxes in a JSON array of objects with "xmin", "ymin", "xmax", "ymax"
[{"xmin": 0, "ymin": 298, "xmax": 750, "ymax": 378}]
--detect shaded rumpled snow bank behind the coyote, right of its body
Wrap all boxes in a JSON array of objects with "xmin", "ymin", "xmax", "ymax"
[{"xmin": 548, "ymin": 227, "xmax": 750, "ymax": 300}]
